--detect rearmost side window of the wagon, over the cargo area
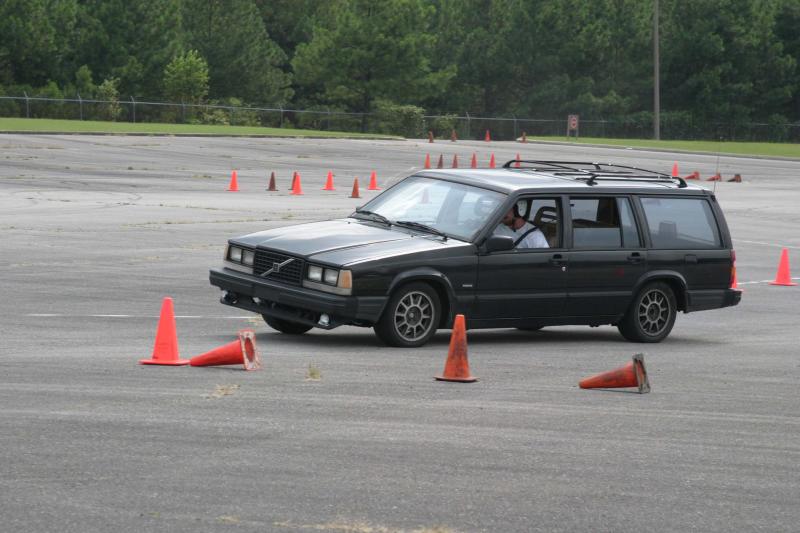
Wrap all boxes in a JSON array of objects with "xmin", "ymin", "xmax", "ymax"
[{"xmin": 640, "ymin": 197, "xmax": 722, "ymax": 249}]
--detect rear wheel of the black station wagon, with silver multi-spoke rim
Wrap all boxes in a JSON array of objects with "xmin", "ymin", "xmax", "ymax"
[{"xmin": 617, "ymin": 281, "xmax": 678, "ymax": 342}]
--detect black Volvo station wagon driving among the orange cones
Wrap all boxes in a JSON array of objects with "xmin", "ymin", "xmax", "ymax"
[{"xmin": 210, "ymin": 160, "xmax": 741, "ymax": 347}]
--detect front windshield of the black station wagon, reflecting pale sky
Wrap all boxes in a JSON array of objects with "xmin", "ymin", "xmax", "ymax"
[{"xmin": 352, "ymin": 176, "xmax": 506, "ymax": 241}]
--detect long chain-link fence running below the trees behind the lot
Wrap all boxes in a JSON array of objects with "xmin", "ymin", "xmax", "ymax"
[{"xmin": 0, "ymin": 94, "xmax": 800, "ymax": 143}]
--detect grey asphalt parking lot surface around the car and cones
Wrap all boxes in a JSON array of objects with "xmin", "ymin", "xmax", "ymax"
[{"xmin": 0, "ymin": 135, "xmax": 800, "ymax": 533}]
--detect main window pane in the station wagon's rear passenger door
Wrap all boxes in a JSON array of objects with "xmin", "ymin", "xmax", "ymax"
[{"xmin": 570, "ymin": 198, "xmax": 622, "ymax": 249}]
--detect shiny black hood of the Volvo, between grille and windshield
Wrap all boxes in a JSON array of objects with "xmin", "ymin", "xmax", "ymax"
[{"xmin": 234, "ymin": 219, "xmax": 466, "ymax": 265}]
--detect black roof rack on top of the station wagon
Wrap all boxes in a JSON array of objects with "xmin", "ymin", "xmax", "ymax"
[{"xmin": 503, "ymin": 159, "xmax": 687, "ymax": 189}]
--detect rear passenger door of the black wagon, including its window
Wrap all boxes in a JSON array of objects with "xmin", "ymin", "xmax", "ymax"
[{"xmin": 565, "ymin": 195, "xmax": 647, "ymax": 317}]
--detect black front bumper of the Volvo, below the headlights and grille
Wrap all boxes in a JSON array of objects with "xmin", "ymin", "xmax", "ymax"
[{"xmin": 209, "ymin": 268, "xmax": 387, "ymax": 329}]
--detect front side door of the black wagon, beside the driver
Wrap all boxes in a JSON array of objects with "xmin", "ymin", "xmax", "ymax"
[{"xmin": 475, "ymin": 195, "xmax": 568, "ymax": 321}]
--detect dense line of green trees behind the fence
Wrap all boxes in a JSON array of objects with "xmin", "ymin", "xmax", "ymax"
[{"xmin": 0, "ymin": 0, "xmax": 800, "ymax": 137}]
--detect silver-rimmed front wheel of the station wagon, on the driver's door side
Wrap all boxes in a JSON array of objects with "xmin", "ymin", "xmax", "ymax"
[{"xmin": 374, "ymin": 282, "xmax": 442, "ymax": 348}]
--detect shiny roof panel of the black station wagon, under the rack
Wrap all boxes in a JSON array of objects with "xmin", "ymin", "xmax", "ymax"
[{"xmin": 415, "ymin": 168, "xmax": 707, "ymax": 194}]
